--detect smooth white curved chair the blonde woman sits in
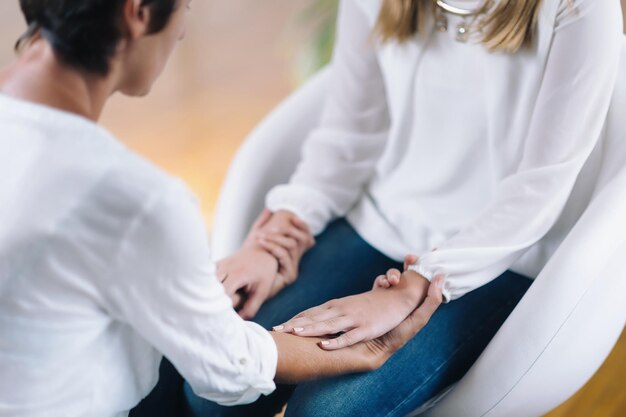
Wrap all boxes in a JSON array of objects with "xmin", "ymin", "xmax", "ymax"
[{"xmin": 213, "ymin": 42, "xmax": 626, "ymax": 417}]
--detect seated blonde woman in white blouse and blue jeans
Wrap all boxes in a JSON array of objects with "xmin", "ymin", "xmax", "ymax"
[{"xmin": 186, "ymin": 0, "xmax": 622, "ymax": 417}]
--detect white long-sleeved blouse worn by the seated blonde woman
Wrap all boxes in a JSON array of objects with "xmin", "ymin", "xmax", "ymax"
[{"xmin": 266, "ymin": 0, "xmax": 623, "ymax": 301}]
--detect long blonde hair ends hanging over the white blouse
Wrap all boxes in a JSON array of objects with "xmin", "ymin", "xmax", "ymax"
[{"xmin": 374, "ymin": 0, "xmax": 541, "ymax": 53}]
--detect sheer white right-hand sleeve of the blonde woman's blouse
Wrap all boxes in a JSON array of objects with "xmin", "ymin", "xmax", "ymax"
[{"xmin": 411, "ymin": 0, "xmax": 623, "ymax": 301}]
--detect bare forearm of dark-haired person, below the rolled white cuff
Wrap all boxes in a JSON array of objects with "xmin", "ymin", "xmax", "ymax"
[{"xmin": 271, "ymin": 332, "xmax": 386, "ymax": 384}]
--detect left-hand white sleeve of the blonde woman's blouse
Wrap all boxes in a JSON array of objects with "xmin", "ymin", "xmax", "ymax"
[{"xmin": 266, "ymin": 0, "xmax": 389, "ymax": 235}]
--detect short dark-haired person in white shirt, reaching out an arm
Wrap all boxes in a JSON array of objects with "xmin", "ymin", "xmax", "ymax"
[{"xmin": 0, "ymin": 0, "xmax": 441, "ymax": 417}]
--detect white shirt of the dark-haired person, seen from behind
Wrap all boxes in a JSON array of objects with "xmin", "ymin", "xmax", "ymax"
[{"xmin": 0, "ymin": 95, "xmax": 277, "ymax": 417}]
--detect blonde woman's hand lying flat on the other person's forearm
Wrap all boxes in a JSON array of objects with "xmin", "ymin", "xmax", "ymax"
[{"xmin": 274, "ymin": 271, "xmax": 436, "ymax": 350}]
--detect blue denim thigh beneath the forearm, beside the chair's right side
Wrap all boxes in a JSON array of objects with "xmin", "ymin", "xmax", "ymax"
[{"xmin": 285, "ymin": 266, "xmax": 532, "ymax": 417}]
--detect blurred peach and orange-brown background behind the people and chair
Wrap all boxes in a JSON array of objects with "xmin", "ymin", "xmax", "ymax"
[{"xmin": 0, "ymin": 0, "xmax": 626, "ymax": 417}]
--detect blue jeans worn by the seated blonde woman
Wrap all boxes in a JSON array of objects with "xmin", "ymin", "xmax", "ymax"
[{"xmin": 177, "ymin": 219, "xmax": 532, "ymax": 417}]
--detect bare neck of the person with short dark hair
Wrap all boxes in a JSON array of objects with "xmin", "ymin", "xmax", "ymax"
[{"xmin": 0, "ymin": 39, "xmax": 116, "ymax": 121}]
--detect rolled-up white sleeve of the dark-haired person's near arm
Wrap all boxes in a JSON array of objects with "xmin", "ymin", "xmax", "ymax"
[{"xmin": 104, "ymin": 182, "xmax": 277, "ymax": 405}]
